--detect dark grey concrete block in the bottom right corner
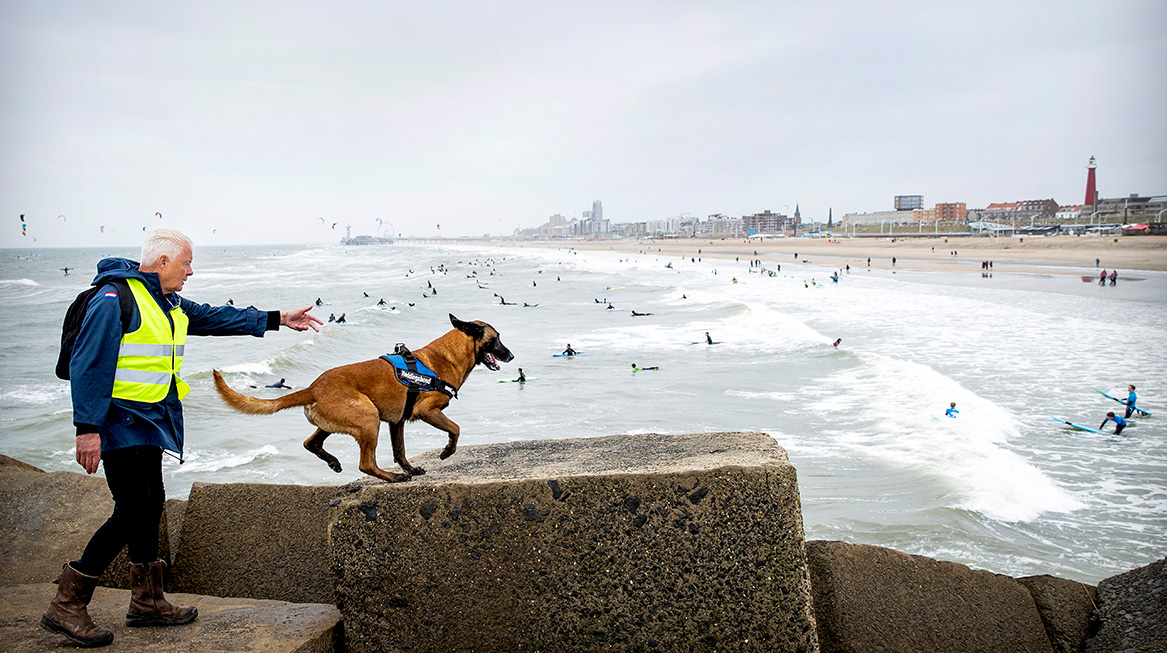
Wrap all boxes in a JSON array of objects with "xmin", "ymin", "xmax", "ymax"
[{"xmin": 1085, "ymin": 557, "xmax": 1167, "ymax": 653}]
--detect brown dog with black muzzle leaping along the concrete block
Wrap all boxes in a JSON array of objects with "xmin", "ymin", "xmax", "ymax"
[{"xmin": 215, "ymin": 315, "xmax": 515, "ymax": 483}]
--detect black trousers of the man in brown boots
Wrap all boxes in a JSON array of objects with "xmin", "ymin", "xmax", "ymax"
[{"xmin": 74, "ymin": 447, "xmax": 166, "ymax": 576}]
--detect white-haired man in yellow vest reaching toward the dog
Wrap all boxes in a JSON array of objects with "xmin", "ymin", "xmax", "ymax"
[{"xmin": 41, "ymin": 227, "xmax": 320, "ymax": 646}]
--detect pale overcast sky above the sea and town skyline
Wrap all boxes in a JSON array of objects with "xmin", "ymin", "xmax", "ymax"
[{"xmin": 0, "ymin": 0, "xmax": 1167, "ymax": 247}]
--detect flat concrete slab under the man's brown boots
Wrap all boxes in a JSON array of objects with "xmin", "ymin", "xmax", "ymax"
[{"xmin": 0, "ymin": 584, "xmax": 343, "ymax": 653}]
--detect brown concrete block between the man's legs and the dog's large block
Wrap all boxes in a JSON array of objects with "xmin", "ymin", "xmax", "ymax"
[{"xmin": 173, "ymin": 483, "xmax": 345, "ymax": 603}]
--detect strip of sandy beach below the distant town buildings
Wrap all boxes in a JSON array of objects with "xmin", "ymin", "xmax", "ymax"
[{"xmin": 506, "ymin": 236, "xmax": 1167, "ymax": 278}]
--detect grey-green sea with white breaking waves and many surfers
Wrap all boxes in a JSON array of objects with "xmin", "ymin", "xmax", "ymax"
[{"xmin": 0, "ymin": 243, "xmax": 1167, "ymax": 583}]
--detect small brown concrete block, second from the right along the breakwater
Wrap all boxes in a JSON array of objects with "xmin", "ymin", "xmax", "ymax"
[{"xmin": 1018, "ymin": 575, "xmax": 1098, "ymax": 653}]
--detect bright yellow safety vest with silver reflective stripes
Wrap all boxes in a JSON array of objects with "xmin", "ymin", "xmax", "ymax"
[{"xmin": 113, "ymin": 279, "xmax": 190, "ymax": 403}]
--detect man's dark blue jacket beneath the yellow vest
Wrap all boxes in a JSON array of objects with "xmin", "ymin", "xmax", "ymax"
[{"xmin": 69, "ymin": 258, "xmax": 280, "ymax": 455}]
